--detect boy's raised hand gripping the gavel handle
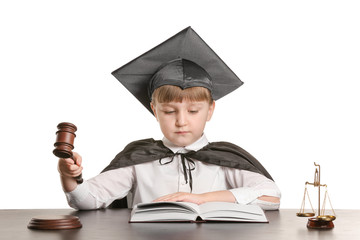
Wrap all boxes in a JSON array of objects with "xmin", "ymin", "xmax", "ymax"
[{"xmin": 58, "ymin": 152, "xmax": 83, "ymax": 178}]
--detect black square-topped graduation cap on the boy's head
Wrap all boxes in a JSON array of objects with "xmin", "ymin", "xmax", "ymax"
[{"xmin": 112, "ymin": 27, "xmax": 243, "ymax": 113}]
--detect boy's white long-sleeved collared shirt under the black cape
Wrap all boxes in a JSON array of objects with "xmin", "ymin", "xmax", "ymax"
[{"xmin": 65, "ymin": 135, "xmax": 281, "ymax": 210}]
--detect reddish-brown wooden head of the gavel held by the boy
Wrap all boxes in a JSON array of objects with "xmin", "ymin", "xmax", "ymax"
[{"xmin": 53, "ymin": 122, "xmax": 77, "ymax": 158}]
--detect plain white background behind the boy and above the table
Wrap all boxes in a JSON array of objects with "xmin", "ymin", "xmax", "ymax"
[{"xmin": 0, "ymin": 0, "xmax": 360, "ymax": 209}]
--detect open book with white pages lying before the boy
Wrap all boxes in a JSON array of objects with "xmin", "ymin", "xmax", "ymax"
[{"xmin": 130, "ymin": 202, "xmax": 268, "ymax": 222}]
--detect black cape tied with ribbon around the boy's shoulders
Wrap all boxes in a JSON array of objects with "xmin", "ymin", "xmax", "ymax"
[{"xmin": 102, "ymin": 138, "xmax": 273, "ymax": 207}]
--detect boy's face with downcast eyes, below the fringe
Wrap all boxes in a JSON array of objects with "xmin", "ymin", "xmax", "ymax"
[{"xmin": 151, "ymin": 99, "xmax": 215, "ymax": 147}]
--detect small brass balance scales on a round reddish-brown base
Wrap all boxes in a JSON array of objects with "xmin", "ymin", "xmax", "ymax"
[{"xmin": 296, "ymin": 163, "xmax": 336, "ymax": 229}]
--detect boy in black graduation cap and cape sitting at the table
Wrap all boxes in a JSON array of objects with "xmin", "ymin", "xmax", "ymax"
[{"xmin": 58, "ymin": 28, "xmax": 280, "ymax": 209}]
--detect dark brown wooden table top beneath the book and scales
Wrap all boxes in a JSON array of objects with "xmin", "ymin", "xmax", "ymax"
[{"xmin": 0, "ymin": 209, "xmax": 360, "ymax": 240}]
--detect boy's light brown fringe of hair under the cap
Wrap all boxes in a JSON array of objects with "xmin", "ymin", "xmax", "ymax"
[{"xmin": 151, "ymin": 85, "xmax": 214, "ymax": 105}]
